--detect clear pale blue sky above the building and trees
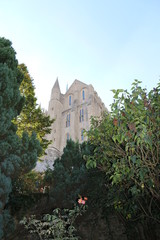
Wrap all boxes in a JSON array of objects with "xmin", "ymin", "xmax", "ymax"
[{"xmin": 0, "ymin": 0, "xmax": 160, "ymax": 109}]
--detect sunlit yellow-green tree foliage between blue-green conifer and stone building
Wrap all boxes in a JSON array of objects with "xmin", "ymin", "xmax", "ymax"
[{"xmin": 10, "ymin": 64, "xmax": 54, "ymax": 202}]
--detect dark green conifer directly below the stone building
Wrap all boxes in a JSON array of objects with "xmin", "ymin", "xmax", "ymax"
[{"xmin": 45, "ymin": 139, "xmax": 89, "ymax": 208}]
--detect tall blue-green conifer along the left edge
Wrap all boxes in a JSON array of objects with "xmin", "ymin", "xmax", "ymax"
[{"xmin": 0, "ymin": 38, "xmax": 41, "ymax": 239}]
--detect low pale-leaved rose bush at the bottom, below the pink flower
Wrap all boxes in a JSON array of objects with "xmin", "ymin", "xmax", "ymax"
[{"xmin": 21, "ymin": 205, "xmax": 86, "ymax": 240}]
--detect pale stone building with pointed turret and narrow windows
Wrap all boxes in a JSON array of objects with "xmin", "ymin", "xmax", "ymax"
[{"xmin": 35, "ymin": 79, "xmax": 107, "ymax": 170}]
